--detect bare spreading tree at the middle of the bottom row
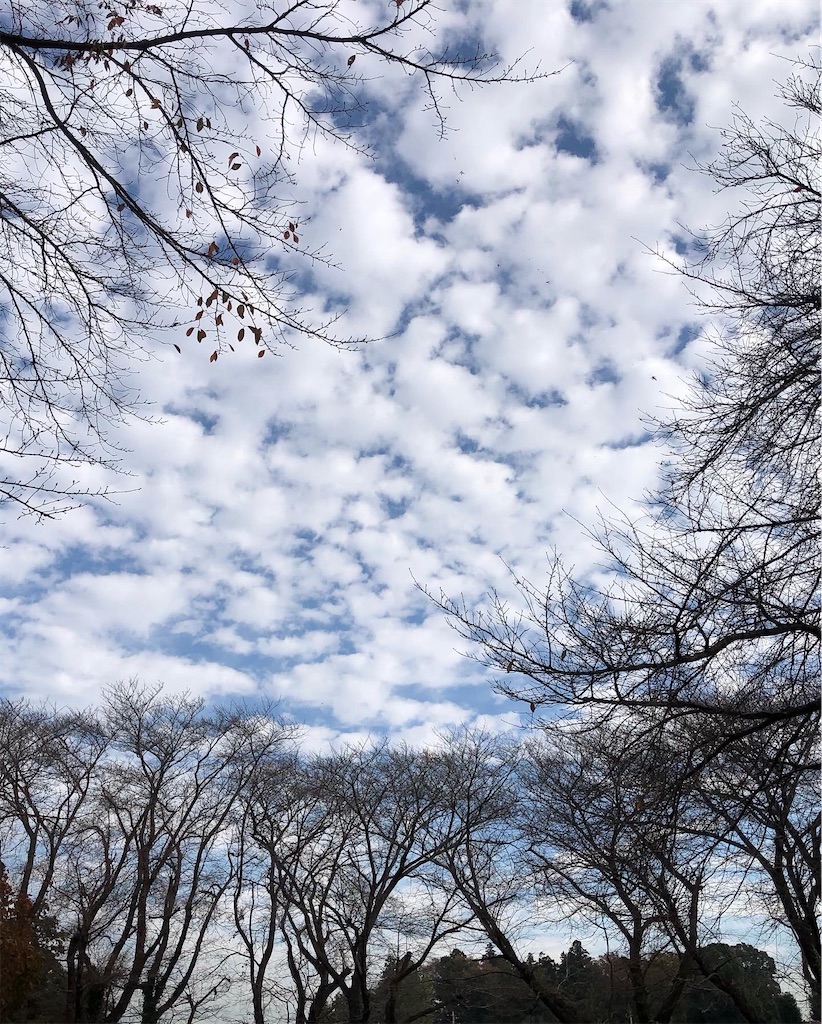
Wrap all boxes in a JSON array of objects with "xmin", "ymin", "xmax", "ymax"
[{"xmin": 244, "ymin": 743, "xmax": 471, "ymax": 1022}]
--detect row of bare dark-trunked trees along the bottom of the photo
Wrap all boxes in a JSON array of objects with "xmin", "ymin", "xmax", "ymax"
[{"xmin": 0, "ymin": 683, "xmax": 819, "ymax": 1024}]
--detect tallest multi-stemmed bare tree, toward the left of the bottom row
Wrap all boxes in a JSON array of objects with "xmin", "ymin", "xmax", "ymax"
[{"xmin": 88, "ymin": 687, "xmax": 285, "ymax": 1024}]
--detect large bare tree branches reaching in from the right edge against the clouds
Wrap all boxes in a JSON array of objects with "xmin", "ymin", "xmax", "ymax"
[{"xmin": 437, "ymin": 63, "xmax": 822, "ymax": 771}]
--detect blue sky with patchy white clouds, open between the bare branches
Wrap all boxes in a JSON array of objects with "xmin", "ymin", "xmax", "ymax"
[{"xmin": 0, "ymin": 0, "xmax": 819, "ymax": 748}]
